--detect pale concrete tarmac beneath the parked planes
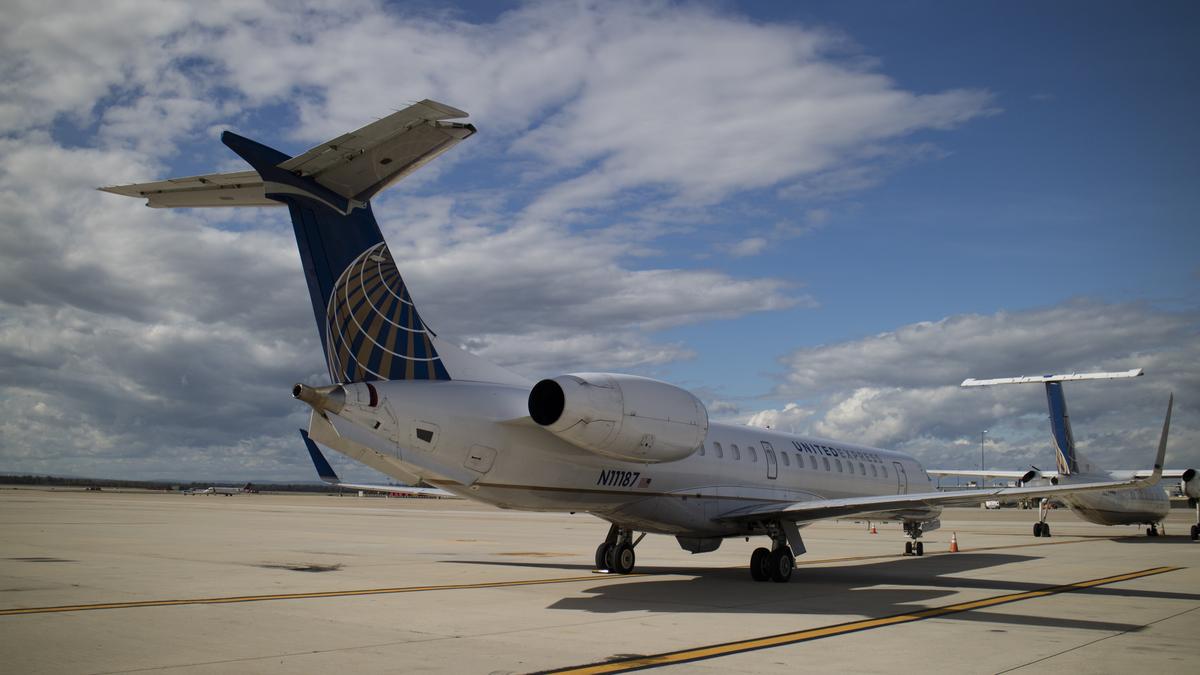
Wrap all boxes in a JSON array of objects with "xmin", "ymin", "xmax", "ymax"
[{"xmin": 0, "ymin": 489, "xmax": 1200, "ymax": 674}]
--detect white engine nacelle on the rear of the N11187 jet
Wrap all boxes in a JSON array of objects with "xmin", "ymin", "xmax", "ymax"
[{"xmin": 529, "ymin": 372, "xmax": 708, "ymax": 462}]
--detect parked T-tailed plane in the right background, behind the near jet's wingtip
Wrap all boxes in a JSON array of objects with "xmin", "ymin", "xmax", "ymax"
[{"xmin": 929, "ymin": 368, "xmax": 1200, "ymax": 540}]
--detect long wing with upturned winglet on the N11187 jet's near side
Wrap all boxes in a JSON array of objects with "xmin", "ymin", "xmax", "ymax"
[{"xmin": 716, "ymin": 394, "xmax": 1175, "ymax": 522}]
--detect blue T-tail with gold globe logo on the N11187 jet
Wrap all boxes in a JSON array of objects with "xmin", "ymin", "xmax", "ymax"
[{"xmin": 101, "ymin": 100, "xmax": 526, "ymax": 384}]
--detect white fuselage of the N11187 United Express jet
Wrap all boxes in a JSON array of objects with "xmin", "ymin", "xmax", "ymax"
[{"xmin": 310, "ymin": 381, "xmax": 940, "ymax": 537}]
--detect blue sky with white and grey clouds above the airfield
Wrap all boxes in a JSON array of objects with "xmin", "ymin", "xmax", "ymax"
[{"xmin": 0, "ymin": 0, "xmax": 1200, "ymax": 479}]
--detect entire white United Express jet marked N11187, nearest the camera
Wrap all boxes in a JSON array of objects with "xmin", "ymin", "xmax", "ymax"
[{"xmin": 103, "ymin": 101, "xmax": 1170, "ymax": 581}]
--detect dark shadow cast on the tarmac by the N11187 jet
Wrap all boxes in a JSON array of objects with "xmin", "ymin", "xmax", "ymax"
[{"xmin": 454, "ymin": 552, "xmax": 1200, "ymax": 632}]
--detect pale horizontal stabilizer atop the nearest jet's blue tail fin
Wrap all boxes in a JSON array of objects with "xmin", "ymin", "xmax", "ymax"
[{"xmin": 101, "ymin": 100, "xmax": 475, "ymax": 208}]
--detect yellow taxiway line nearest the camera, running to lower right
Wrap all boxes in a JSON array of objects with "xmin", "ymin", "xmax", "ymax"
[{"xmin": 541, "ymin": 567, "xmax": 1182, "ymax": 675}]
